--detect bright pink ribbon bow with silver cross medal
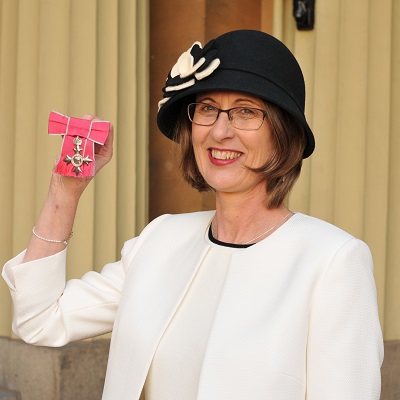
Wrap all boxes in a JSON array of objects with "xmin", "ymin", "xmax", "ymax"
[{"xmin": 48, "ymin": 111, "xmax": 110, "ymax": 178}]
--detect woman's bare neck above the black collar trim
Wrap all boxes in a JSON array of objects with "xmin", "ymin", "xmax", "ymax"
[{"xmin": 212, "ymin": 189, "xmax": 290, "ymax": 244}]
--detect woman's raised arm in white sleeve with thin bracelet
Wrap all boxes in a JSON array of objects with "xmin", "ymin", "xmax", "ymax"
[{"xmin": 2, "ymin": 115, "xmax": 122, "ymax": 346}]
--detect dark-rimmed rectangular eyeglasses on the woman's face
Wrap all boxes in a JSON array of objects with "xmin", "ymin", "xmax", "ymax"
[{"xmin": 187, "ymin": 103, "xmax": 267, "ymax": 131}]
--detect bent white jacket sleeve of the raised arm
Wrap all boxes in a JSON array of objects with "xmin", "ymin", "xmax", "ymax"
[{"xmin": 2, "ymin": 239, "xmax": 137, "ymax": 347}]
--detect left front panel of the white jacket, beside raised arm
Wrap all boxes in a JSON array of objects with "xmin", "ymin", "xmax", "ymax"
[{"xmin": 103, "ymin": 212, "xmax": 213, "ymax": 400}]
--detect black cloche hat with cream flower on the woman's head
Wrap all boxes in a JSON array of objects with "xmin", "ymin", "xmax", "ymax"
[{"xmin": 157, "ymin": 30, "xmax": 315, "ymax": 158}]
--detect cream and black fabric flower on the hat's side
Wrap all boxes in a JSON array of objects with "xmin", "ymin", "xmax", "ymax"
[{"xmin": 158, "ymin": 40, "xmax": 220, "ymax": 109}]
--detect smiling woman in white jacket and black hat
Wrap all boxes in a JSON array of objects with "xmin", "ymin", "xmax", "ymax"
[{"xmin": 3, "ymin": 31, "xmax": 383, "ymax": 400}]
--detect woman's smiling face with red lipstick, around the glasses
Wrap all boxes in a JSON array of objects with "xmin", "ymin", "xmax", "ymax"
[{"xmin": 192, "ymin": 91, "xmax": 274, "ymax": 197}]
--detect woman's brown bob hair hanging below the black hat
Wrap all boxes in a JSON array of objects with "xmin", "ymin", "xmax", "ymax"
[{"xmin": 174, "ymin": 101, "xmax": 306, "ymax": 209}]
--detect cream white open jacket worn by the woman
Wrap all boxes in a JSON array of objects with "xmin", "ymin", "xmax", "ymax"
[{"xmin": 3, "ymin": 212, "xmax": 383, "ymax": 400}]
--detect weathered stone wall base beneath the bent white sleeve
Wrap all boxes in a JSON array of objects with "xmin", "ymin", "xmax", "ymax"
[{"xmin": 0, "ymin": 338, "xmax": 110, "ymax": 400}]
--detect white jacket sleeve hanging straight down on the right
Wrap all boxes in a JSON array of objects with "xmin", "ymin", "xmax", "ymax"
[{"xmin": 307, "ymin": 238, "xmax": 383, "ymax": 400}]
